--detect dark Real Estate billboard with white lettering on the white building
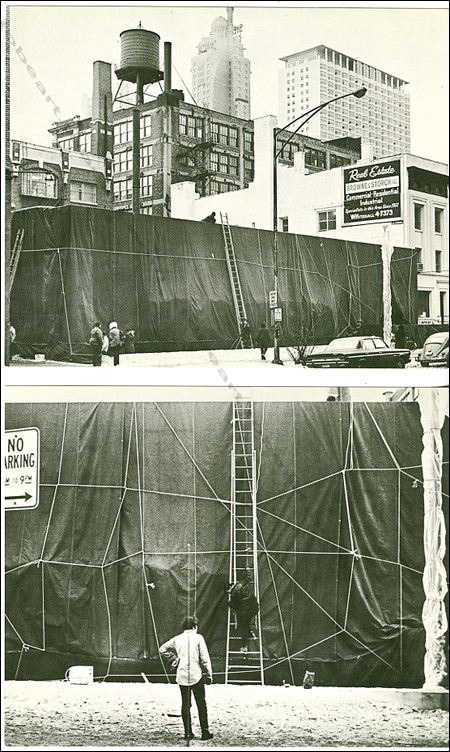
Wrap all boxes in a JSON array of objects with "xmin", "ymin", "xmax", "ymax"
[{"xmin": 342, "ymin": 159, "xmax": 402, "ymax": 227}]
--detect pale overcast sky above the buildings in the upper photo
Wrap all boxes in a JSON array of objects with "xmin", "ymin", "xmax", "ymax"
[{"xmin": 2, "ymin": 2, "xmax": 448, "ymax": 163}]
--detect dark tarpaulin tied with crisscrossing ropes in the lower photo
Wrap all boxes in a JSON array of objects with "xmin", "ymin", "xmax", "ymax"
[{"xmin": 5, "ymin": 402, "xmax": 448, "ymax": 687}]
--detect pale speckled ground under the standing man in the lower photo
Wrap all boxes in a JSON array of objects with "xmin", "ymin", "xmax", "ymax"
[{"xmin": 2, "ymin": 681, "xmax": 448, "ymax": 749}]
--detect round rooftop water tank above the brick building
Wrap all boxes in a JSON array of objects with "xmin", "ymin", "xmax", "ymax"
[{"xmin": 116, "ymin": 28, "xmax": 163, "ymax": 84}]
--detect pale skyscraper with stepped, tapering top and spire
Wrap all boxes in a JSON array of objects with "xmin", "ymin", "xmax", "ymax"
[{"xmin": 191, "ymin": 8, "xmax": 250, "ymax": 120}]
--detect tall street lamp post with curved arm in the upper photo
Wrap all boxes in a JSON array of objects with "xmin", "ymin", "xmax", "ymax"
[{"xmin": 272, "ymin": 87, "xmax": 367, "ymax": 366}]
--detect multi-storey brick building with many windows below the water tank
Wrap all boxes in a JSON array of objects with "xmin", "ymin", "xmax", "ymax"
[{"xmin": 50, "ymin": 61, "xmax": 360, "ymax": 216}]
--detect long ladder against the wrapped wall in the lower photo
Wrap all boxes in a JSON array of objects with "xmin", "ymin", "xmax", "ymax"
[{"xmin": 225, "ymin": 399, "xmax": 264, "ymax": 684}]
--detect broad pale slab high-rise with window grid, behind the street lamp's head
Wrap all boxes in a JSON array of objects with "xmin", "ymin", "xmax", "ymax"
[{"xmin": 278, "ymin": 45, "xmax": 411, "ymax": 158}]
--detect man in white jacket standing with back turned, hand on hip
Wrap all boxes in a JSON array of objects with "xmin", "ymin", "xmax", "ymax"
[{"xmin": 159, "ymin": 616, "xmax": 213, "ymax": 741}]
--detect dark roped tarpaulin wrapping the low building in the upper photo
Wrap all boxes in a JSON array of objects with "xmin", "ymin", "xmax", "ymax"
[{"xmin": 11, "ymin": 206, "xmax": 417, "ymax": 361}]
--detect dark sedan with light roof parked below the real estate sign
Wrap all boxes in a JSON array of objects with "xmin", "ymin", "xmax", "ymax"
[{"xmin": 305, "ymin": 337, "xmax": 411, "ymax": 368}]
